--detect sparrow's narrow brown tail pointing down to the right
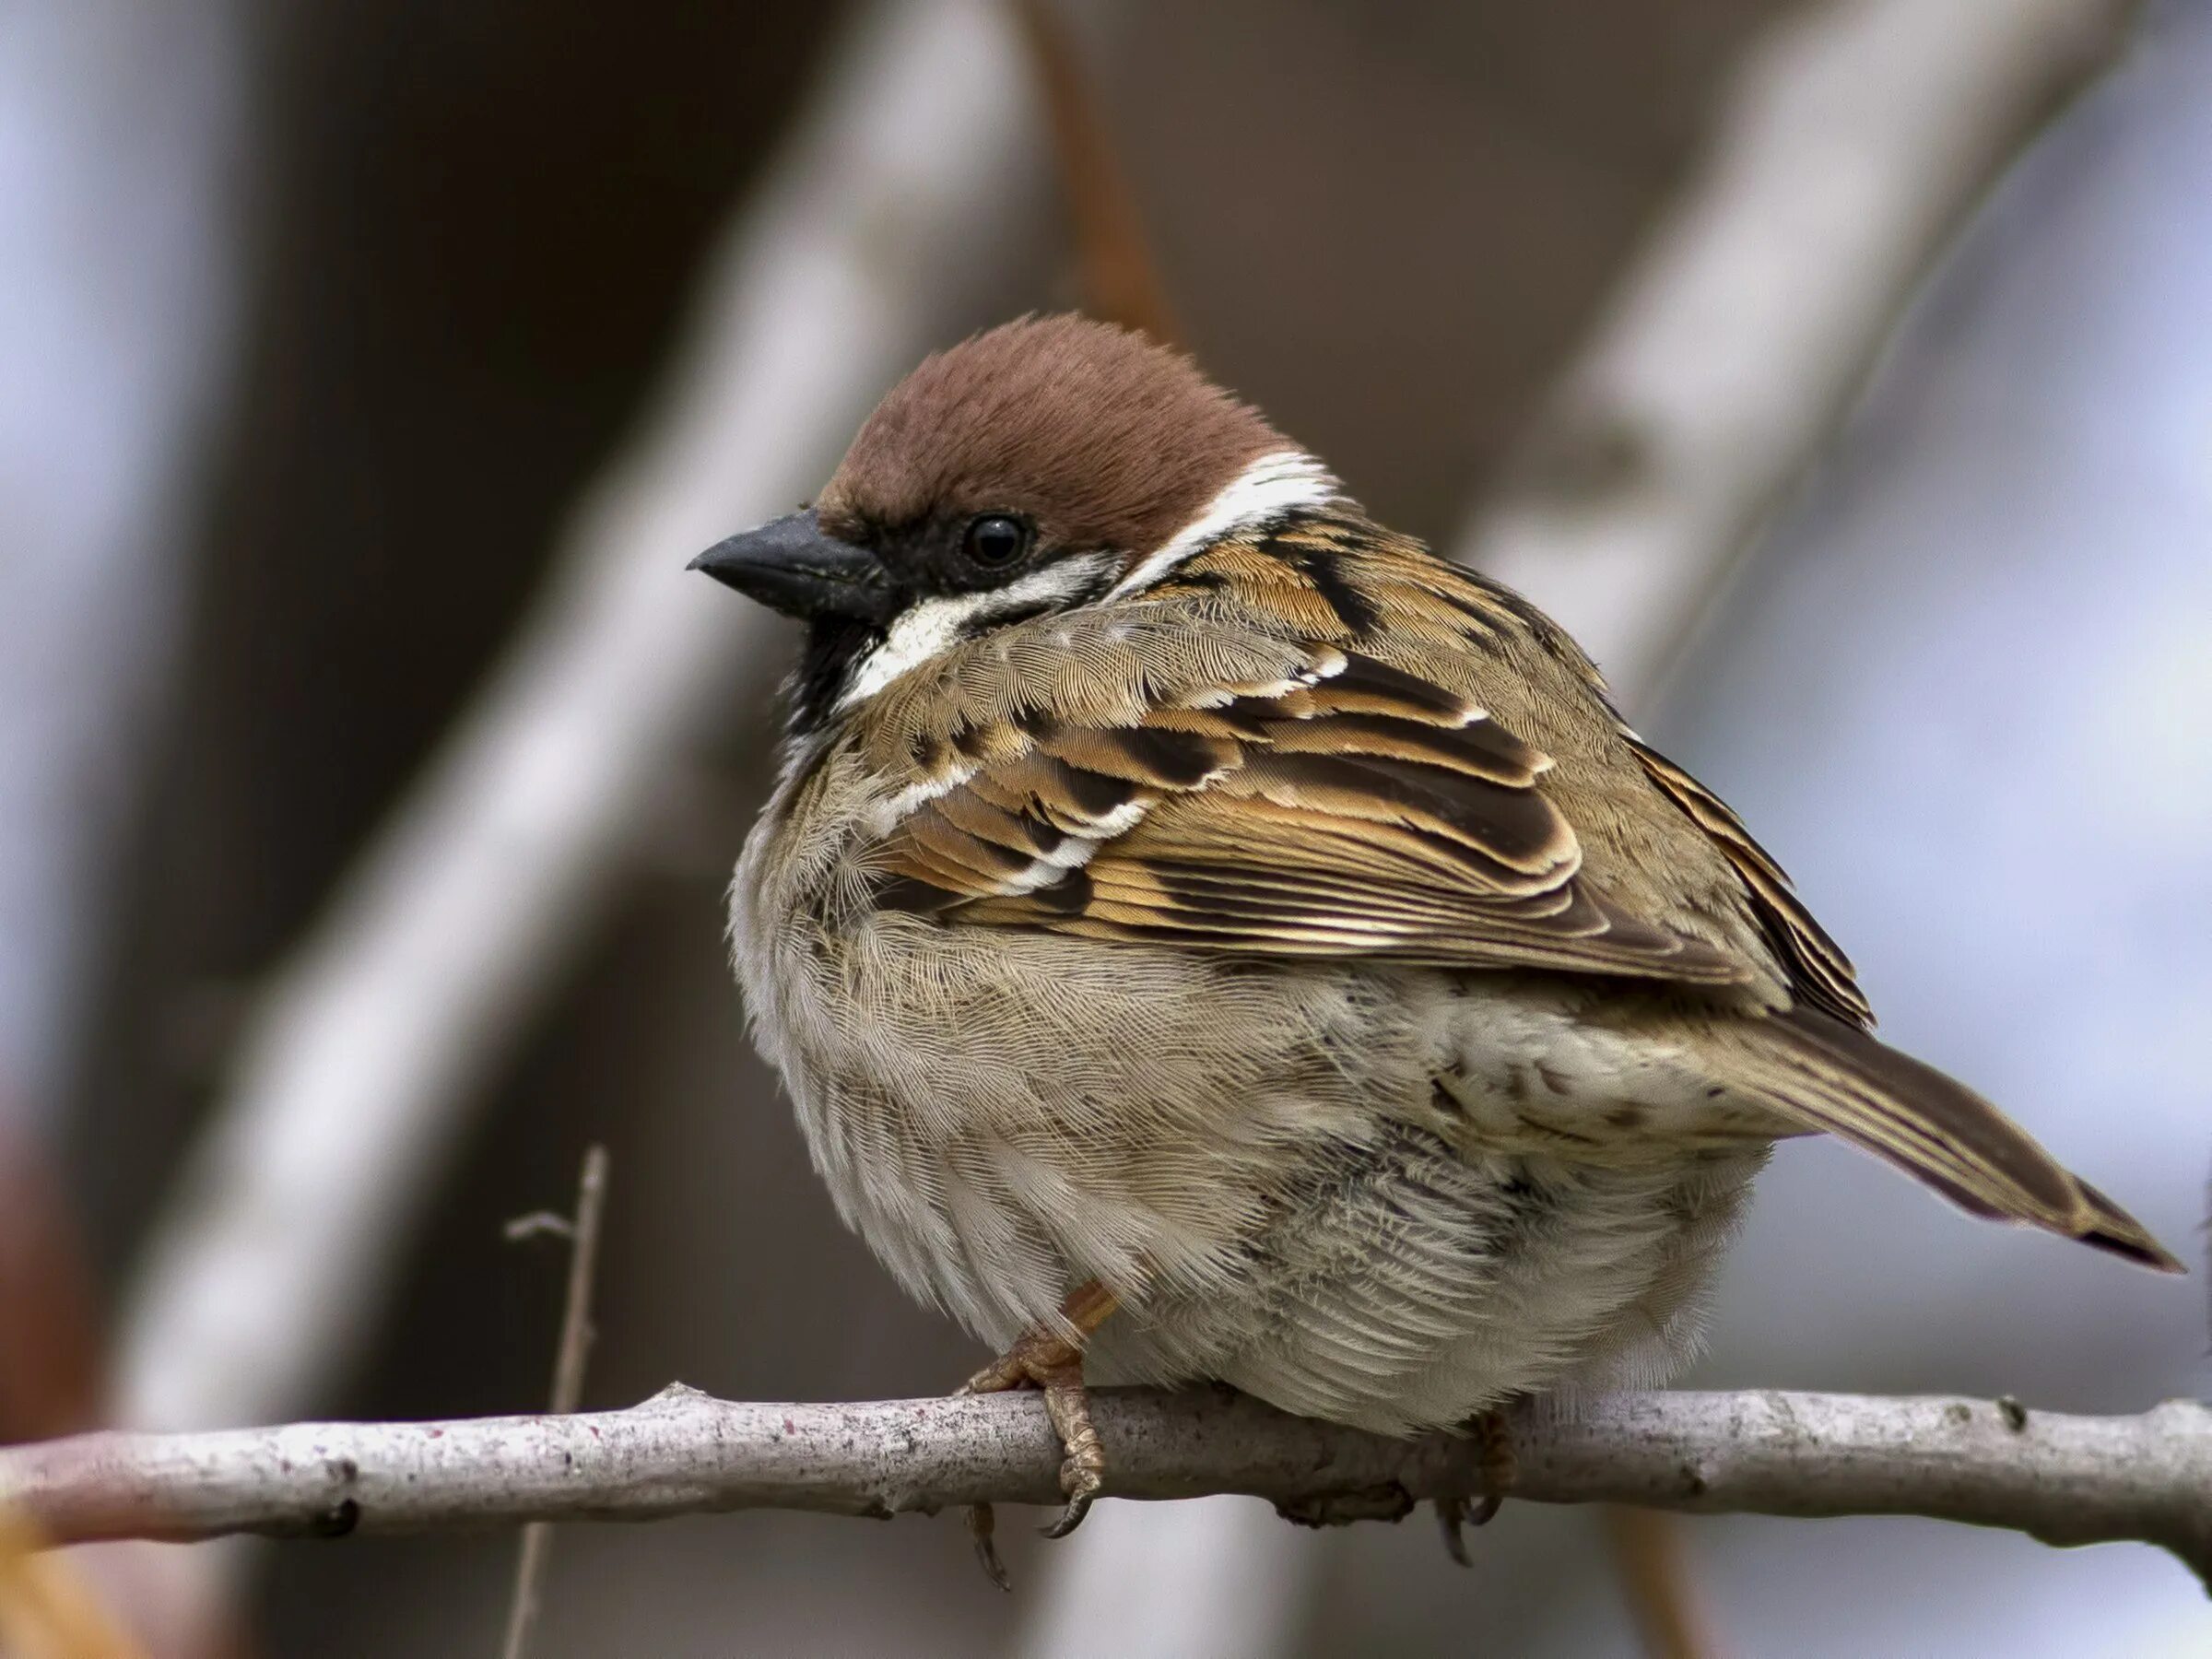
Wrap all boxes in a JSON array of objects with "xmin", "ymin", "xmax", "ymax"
[{"xmin": 1736, "ymin": 1008, "xmax": 2185, "ymax": 1274}]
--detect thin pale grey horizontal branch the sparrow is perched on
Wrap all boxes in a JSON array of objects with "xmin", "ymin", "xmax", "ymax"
[{"xmin": 0, "ymin": 1384, "xmax": 2212, "ymax": 1586}]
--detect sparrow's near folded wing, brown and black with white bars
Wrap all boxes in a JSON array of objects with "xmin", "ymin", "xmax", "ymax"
[{"xmin": 872, "ymin": 618, "xmax": 1746, "ymax": 984}]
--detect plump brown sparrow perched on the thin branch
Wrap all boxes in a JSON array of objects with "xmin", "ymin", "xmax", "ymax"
[{"xmin": 695, "ymin": 316, "xmax": 2181, "ymax": 1566}]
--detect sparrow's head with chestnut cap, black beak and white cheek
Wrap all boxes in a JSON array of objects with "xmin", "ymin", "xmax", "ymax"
[{"xmin": 692, "ymin": 316, "xmax": 1338, "ymax": 728}]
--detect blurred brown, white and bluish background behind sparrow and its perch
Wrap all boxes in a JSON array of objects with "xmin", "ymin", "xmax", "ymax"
[{"xmin": 0, "ymin": 0, "xmax": 2212, "ymax": 1657}]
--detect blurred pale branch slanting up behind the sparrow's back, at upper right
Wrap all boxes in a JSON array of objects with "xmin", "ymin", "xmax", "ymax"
[{"xmin": 1455, "ymin": 0, "xmax": 2139, "ymax": 703}]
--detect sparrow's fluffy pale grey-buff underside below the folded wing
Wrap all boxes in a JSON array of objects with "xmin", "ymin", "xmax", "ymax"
[{"xmin": 741, "ymin": 920, "xmax": 1765, "ymax": 1429}]
